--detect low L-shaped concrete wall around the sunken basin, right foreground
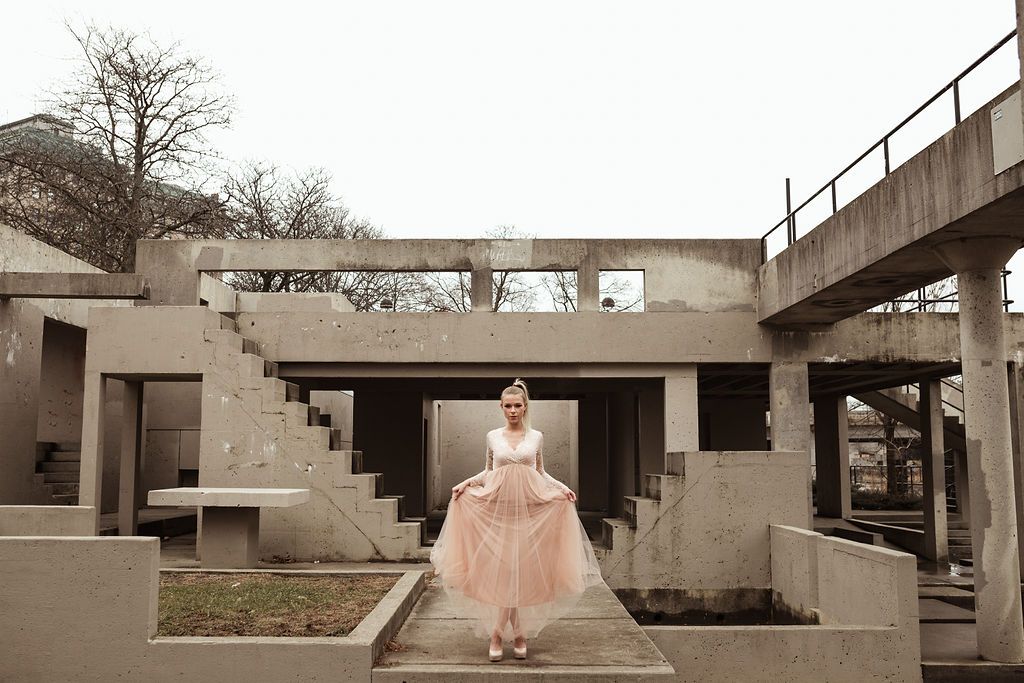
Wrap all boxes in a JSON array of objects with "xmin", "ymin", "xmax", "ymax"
[{"xmin": 644, "ymin": 525, "xmax": 921, "ymax": 683}]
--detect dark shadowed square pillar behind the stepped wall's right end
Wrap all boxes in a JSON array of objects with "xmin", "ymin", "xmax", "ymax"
[{"xmin": 814, "ymin": 395, "xmax": 851, "ymax": 519}]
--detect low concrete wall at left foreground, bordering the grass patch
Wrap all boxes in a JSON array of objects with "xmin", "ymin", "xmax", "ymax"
[{"xmin": 0, "ymin": 538, "xmax": 424, "ymax": 683}]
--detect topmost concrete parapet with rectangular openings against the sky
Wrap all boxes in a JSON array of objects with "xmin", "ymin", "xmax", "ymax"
[{"xmin": 135, "ymin": 240, "xmax": 761, "ymax": 311}]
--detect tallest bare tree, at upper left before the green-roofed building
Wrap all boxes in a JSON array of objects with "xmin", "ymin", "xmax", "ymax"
[{"xmin": 0, "ymin": 25, "xmax": 233, "ymax": 271}]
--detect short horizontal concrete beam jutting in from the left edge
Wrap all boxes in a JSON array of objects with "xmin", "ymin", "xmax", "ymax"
[{"xmin": 0, "ymin": 272, "xmax": 150, "ymax": 299}]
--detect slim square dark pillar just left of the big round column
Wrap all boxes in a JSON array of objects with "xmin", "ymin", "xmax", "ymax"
[{"xmin": 918, "ymin": 379, "xmax": 949, "ymax": 562}]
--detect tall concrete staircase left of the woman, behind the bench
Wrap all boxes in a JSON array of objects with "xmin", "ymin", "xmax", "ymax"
[{"xmin": 200, "ymin": 317, "xmax": 430, "ymax": 561}]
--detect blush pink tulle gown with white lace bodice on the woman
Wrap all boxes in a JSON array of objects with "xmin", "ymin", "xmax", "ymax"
[{"xmin": 430, "ymin": 429, "xmax": 602, "ymax": 638}]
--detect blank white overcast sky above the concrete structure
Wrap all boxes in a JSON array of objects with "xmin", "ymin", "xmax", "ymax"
[{"xmin": 6, "ymin": 0, "xmax": 1024, "ymax": 310}]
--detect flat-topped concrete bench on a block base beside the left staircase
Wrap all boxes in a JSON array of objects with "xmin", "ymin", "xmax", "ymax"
[{"xmin": 147, "ymin": 486, "xmax": 309, "ymax": 568}]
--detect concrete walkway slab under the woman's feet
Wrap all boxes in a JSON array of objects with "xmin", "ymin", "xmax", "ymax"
[{"xmin": 373, "ymin": 583, "xmax": 675, "ymax": 683}]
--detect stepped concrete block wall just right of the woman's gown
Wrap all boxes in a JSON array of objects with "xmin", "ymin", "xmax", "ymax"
[{"xmin": 595, "ymin": 451, "xmax": 807, "ymax": 604}]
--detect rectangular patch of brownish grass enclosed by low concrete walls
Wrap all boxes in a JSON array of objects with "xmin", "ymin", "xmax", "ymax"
[{"xmin": 157, "ymin": 572, "xmax": 399, "ymax": 637}]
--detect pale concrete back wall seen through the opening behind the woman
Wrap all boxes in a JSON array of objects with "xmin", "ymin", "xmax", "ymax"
[{"xmin": 430, "ymin": 399, "xmax": 584, "ymax": 511}]
